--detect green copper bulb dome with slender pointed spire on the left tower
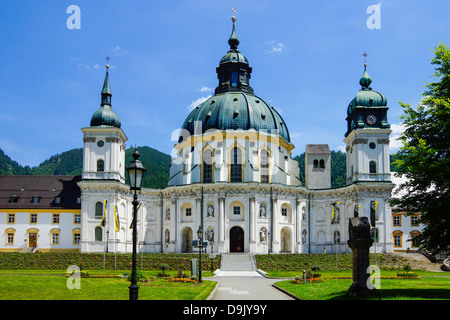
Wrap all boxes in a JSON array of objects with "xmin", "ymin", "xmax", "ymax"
[{"xmin": 91, "ymin": 66, "xmax": 121, "ymax": 128}]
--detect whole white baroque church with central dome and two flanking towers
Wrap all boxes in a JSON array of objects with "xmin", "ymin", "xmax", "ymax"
[{"xmin": 78, "ymin": 19, "xmax": 394, "ymax": 254}]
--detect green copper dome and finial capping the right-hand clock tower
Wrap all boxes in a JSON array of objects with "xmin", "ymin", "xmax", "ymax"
[{"xmin": 347, "ymin": 68, "xmax": 387, "ymax": 115}]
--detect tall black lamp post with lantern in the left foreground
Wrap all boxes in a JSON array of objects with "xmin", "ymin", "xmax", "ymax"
[{"xmin": 127, "ymin": 149, "xmax": 146, "ymax": 300}]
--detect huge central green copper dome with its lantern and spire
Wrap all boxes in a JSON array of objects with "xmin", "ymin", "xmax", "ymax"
[{"xmin": 179, "ymin": 16, "xmax": 290, "ymax": 142}]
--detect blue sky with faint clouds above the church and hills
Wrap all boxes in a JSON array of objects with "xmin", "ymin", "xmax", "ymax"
[{"xmin": 0, "ymin": 0, "xmax": 450, "ymax": 166}]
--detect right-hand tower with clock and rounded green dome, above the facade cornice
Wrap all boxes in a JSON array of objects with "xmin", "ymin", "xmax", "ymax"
[{"xmin": 344, "ymin": 63, "xmax": 391, "ymax": 185}]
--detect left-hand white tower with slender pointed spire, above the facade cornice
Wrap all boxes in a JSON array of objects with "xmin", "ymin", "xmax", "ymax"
[{"xmin": 81, "ymin": 64, "xmax": 128, "ymax": 183}]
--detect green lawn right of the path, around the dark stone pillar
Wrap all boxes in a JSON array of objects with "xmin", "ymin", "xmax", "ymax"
[{"xmin": 275, "ymin": 277, "xmax": 450, "ymax": 300}]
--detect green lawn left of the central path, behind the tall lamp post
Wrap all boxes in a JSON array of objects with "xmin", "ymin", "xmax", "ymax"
[{"xmin": 0, "ymin": 270, "xmax": 216, "ymax": 300}]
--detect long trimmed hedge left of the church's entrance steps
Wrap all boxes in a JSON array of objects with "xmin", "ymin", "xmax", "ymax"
[{"xmin": 0, "ymin": 252, "xmax": 221, "ymax": 270}]
